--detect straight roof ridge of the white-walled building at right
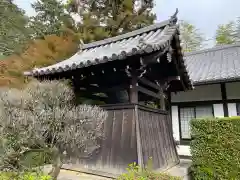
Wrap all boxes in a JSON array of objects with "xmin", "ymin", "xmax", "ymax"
[{"xmin": 184, "ymin": 43, "xmax": 240, "ymax": 57}]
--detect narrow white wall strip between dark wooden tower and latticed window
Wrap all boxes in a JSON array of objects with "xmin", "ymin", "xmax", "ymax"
[{"xmin": 171, "ymin": 106, "xmax": 180, "ymax": 141}]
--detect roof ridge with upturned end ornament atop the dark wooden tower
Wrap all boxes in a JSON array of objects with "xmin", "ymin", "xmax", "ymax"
[{"xmin": 82, "ymin": 9, "xmax": 178, "ymax": 50}]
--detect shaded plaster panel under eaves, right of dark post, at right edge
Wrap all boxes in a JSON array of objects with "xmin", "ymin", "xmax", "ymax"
[{"xmin": 226, "ymin": 82, "xmax": 240, "ymax": 99}]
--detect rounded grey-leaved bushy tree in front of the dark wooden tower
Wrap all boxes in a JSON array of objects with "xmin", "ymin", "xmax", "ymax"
[{"xmin": 0, "ymin": 81, "xmax": 107, "ymax": 180}]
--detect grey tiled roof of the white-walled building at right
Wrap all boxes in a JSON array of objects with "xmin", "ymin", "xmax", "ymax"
[{"xmin": 184, "ymin": 44, "xmax": 240, "ymax": 85}]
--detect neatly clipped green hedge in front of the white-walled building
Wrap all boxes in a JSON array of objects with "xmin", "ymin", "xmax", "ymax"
[{"xmin": 191, "ymin": 117, "xmax": 240, "ymax": 180}]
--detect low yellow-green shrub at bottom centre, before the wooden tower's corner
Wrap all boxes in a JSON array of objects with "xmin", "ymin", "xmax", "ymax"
[{"xmin": 117, "ymin": 163, "xmax": 181, "ymax": 180}]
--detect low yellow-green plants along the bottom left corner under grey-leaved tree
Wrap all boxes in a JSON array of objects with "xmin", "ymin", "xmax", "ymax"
[{"xmin": 0, "ymin": 172, "xmax": 51, "ymax": 180}]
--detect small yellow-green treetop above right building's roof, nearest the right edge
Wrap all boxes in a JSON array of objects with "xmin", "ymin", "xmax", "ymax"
[{"xmin": 215, "ymin": 22, "xmax": 236, "ymax": 45}]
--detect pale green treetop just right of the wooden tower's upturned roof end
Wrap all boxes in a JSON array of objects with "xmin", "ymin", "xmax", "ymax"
[{"xmin": 180, "ymin": 21, "xmax": 204, "ymax": 52}]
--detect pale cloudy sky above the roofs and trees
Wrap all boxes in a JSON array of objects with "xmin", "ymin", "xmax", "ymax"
[{"xmin": 15, "ymin": 0, "xmax": 240, "ymax": 45}]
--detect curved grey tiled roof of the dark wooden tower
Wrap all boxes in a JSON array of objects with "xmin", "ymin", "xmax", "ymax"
[{"xmin": 25, "ymin": 16, "xmax": 178, "ymax": 75}]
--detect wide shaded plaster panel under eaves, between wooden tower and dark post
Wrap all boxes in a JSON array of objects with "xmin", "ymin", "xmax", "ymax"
[{"xmin": 171, "ymin": 84, "xmax": 221, "ymax": 102}]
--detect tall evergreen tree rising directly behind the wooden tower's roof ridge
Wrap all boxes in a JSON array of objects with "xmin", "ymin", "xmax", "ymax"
[{"xmin": 68, "ymin": 0, "xmax": 156, "ymax": 43}]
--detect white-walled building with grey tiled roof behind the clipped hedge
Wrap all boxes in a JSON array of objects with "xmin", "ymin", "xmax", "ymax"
[{"xmin": 171, "ymin": 45, "xmax": 240, "ymax": 156}]
